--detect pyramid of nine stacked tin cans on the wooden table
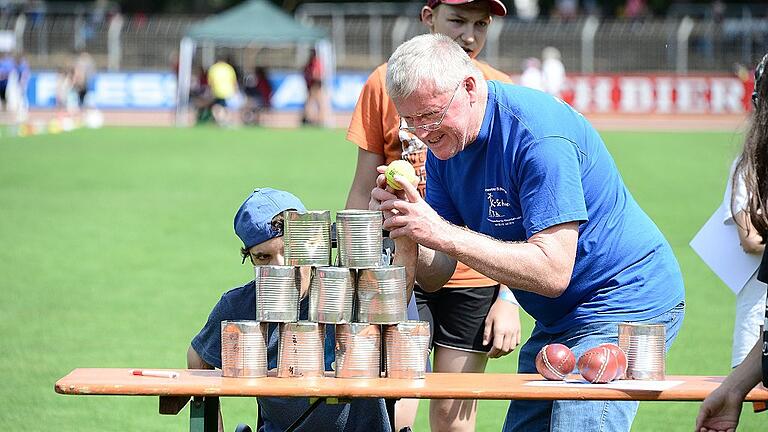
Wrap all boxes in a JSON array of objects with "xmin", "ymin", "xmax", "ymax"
[{"xmin": 222, "ymin": 210, "xmax": 430, "ymax": 378}]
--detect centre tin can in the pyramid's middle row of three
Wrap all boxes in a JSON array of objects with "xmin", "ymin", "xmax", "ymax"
[{"xmin": 309, "ymin": 267, "xmax": 355, "ymax": 324}]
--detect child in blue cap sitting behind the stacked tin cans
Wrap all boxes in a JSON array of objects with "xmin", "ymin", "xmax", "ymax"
[{"xmin": 187, "ymin": 188, "xmax": 402, "ymax": 432}]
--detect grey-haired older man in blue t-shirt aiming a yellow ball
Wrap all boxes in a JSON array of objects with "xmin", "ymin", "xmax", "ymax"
[{"xmin": 371, "ymin": 35, "xmax": 684, "ymax": 432}]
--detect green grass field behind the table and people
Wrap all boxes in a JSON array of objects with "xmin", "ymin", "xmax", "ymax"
[{"xmin": 0, "ymin": 124, "xmax": 766, "ymax": 431}]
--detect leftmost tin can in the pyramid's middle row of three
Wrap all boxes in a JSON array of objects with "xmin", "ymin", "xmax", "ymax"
[{"xmin": 254, "ymin": 265, "xmax": 299, "ymax": 322}]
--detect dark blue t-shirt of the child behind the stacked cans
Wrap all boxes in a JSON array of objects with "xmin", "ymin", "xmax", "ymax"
[{"xmin": 192, "ymin": 281, "xmax": 391, "ymax": 432}]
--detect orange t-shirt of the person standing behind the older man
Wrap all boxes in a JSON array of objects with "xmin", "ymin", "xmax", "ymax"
[{"xmin": 347, "ymin": 60, "xmax": 512, "ymax": 288}]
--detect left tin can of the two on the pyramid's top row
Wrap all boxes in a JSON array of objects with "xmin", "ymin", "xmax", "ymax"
[{"xmin": 283, "ymin": 210, "xmax": 331, "ymax": 266}]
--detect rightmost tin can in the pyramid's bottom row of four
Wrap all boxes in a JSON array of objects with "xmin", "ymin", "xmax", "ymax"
[{"xmin": 384, "ymin": 321, "xmax": 430, "ymax": 379}]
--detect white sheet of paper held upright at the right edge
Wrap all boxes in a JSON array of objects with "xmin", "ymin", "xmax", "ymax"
[{"xmin": 690, "ymin": 205, "xmax": 760, "ymax": 294}]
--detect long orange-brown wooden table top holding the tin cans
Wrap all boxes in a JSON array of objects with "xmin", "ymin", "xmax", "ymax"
[{"xmin": 55, "ymin": 368, "xmax": 768, "ymax": 401}]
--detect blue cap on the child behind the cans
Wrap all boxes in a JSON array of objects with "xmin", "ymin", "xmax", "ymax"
[{"xmin": 235, "ymin": 188, "xmax": 307, "ymax": 249}]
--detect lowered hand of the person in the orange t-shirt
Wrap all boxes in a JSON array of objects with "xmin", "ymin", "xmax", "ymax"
[{"xmin": 483, "ymin": 286, "xmax": 521, "ymax": 358}]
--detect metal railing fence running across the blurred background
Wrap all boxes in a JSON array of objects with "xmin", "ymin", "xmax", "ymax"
[{"xmin": 0, "ymin": 3, "xmax": 768, "ymax": 73}]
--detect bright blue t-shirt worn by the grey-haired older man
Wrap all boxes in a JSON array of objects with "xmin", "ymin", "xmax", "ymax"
[{"xmin": 426, "ymin": 81, "xmax": 684, "ymax": 333}]
